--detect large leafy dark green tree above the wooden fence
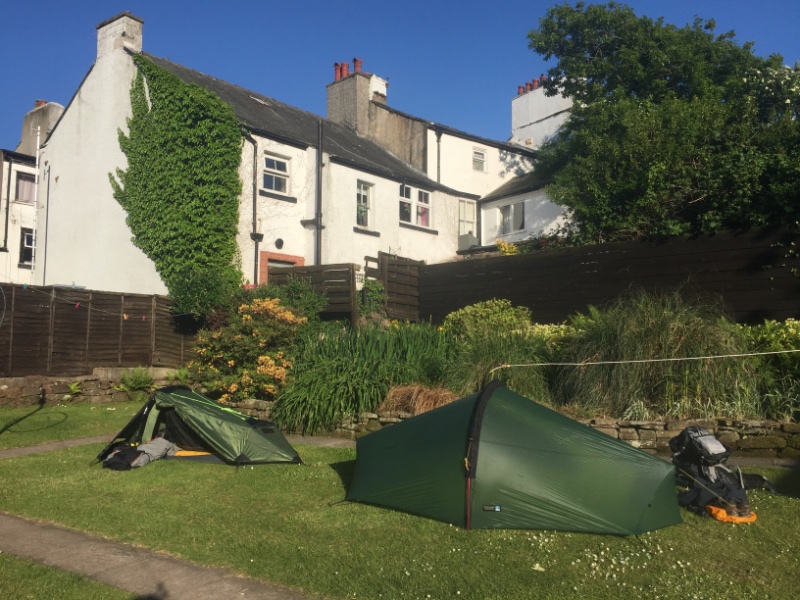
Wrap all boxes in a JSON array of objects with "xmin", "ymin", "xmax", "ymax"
[{"xmin": 529, "ymin": 2, "xmax": 800, "ymax": 243}]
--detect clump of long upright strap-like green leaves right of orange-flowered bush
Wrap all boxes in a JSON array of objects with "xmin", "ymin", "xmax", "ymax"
[{"xmin": 272, "ymin": 323, "xmax": 454, "ymax": 433}]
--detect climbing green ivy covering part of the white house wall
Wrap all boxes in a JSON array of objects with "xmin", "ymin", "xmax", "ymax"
[{"xmin": 109, "ymin": 55, "xmax": 242, "ymax": 317}]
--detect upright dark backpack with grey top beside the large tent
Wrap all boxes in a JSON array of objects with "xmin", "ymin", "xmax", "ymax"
[{"xmin": 669, "ymin": 426, "xmax": 755, "ymax": 522}]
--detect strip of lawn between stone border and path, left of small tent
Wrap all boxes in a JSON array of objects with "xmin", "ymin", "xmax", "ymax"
[{"xmin": 0, "ymin": 402, "xmax": 143, "ymax": 450}]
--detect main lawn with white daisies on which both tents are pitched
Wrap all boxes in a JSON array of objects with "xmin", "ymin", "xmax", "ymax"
[{"xmin": 0, "ymin": 444, "xmax": 800, "ymax": 600}]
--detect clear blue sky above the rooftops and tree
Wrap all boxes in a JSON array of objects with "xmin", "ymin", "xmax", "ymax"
[{"xmin": 0, "ymin": 0, "xmax": 800, "ymax": 150}]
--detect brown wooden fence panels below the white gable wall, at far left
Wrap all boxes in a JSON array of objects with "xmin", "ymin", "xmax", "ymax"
[{"xmin": 0, "ymin": 283, "xmax": 193, "ymax": 377}]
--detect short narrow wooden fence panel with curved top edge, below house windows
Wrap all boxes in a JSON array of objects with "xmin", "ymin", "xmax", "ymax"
[{"xmin": 364, "ymin": 252, "xmax": 424, "ymax": 321}]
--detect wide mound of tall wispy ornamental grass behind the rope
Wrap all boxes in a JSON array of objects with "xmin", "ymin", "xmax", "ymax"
[{"xmin": 554, "ymin": 290, "xmax": 759, "ymax": 419}]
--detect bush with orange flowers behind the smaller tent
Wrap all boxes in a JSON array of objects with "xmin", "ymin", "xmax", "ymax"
[{"xmin": 188, "ymin": 298, "xmax": 307, "ymax": 402}]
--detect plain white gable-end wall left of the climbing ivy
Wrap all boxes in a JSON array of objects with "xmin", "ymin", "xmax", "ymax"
[{"xmin": 34, "ymin": 39, "xmax": 167, "ymax": 294}]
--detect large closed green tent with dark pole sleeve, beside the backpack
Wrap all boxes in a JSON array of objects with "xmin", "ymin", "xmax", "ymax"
[{"xmin": 347, "ymin": 381, "xmax": 681, "ymax": 535}]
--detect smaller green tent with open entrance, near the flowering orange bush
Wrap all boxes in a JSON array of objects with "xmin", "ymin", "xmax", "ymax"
[{"xmin": 97, "ymin": 386, "xmax": 301, "ymax": 465}]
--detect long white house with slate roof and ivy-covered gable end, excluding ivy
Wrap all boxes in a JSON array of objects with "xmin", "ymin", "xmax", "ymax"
[{"xmin": 34, "ymin": 13, "xmax": 552, "ymax": 293}]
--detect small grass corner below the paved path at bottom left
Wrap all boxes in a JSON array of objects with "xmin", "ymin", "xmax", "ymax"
[{"xmin": 0, "ymin": 553, "xmax": 136, "ymax": 600}]
